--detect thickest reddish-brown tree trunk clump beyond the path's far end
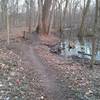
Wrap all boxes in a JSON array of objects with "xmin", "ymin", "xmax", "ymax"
[{"xmin": 36, "ymin": 0, "xmax": 52, "ymax": 35}]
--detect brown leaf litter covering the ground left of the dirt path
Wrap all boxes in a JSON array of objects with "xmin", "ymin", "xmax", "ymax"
[{"xmin": 0, "ymin": 48, "xmax": 44, "ymax": 100}]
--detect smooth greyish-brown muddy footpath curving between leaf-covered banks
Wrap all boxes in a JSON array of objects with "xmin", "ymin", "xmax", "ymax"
[{"xmin": 8, "ymin": 34, "xmax": 73, "ymax": 100}]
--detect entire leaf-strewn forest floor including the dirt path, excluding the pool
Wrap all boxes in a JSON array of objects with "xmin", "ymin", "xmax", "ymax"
[{"xmin": 0, "ymin": 31, "xmax": 100, "ymax": 100}]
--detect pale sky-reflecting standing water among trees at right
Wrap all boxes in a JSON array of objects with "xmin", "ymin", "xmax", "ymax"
[{"xmin": 61, "ymin": 40, "xmax": 100, "ymax": 60}]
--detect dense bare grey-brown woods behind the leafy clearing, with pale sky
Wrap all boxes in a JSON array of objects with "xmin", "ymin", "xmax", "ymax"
[{"xmin": 0, "ymin": 0, "xmax": 100, "ymax": 67}]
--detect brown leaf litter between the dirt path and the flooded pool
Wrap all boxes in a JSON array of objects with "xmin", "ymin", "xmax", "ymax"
[{"xmin": 35, "ymin": 34, "xmax": 100, "ymax": 100}]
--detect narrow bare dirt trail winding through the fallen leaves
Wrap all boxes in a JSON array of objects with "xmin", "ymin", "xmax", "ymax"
[{"xmin": 10, "ymin": 35, "xmax": 69, "ymax": 100}]
